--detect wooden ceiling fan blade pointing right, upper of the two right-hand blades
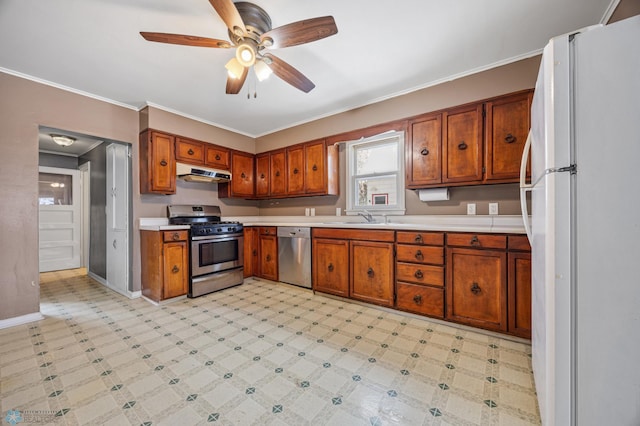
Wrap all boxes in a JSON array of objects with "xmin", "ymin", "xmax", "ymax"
[{"xmin": 260, "ymin": 16, "xmax": 338, "ymax": 48}]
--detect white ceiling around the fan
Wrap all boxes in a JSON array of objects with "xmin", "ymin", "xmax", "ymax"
[{"xmin": 0, "ymin": 0, "xmax": 619, "ymax": 137}]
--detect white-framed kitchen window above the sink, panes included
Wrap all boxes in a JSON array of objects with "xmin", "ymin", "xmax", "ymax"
[{"xmin": 347, "ymin": 131, "xmax": 405, "ymax": 215}]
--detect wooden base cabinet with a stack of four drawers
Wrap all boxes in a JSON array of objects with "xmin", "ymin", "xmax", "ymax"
[{"xmin": 395, "ymin": 231, "xmax": 444, "ymax": 318}]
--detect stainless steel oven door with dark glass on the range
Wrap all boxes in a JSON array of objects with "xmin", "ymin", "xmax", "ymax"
[{"xmin": 191, "ymin": 233, "xmax": 244, "ymax": 277}]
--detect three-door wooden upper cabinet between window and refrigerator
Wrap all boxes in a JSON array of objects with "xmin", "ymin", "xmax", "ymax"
[{"xmin": 406, "ymin": 90, "xmax": 533, "ymax": 189}]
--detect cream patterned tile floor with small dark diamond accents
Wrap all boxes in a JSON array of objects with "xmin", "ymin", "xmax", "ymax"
[{"xmin": 0, "ymin": 270, "xmax": 540, "ymax": 426}]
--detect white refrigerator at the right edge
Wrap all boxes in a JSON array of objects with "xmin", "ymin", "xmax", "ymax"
[{"xmin": 521, "ymin": 16, "xmax": 640, "ymax": 426}]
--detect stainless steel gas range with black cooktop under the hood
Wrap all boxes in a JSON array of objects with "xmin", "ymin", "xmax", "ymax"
[{"xmin": 167, "ymin": 204, "xmax": 244, "ymax": 297}]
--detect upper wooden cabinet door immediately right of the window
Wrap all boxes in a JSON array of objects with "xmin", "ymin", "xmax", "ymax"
[{"xmin": 405, "ymin": 114, "xmax": 442, "ymax": 188}]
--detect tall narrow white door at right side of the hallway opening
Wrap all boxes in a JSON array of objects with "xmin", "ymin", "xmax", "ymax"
[{"xmin": 107, "ymin": 144, "xmax": 129, "ymax": 295}]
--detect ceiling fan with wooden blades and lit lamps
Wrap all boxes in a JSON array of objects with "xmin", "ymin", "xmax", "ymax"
[{"xmin": 140, "ymin": 0, "xmax": 338, "ymax": 94}]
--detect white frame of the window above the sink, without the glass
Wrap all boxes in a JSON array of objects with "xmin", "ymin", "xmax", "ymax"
[{"xmin": 345, "ymin": 130, "xmax": 406, "ymax": 216}]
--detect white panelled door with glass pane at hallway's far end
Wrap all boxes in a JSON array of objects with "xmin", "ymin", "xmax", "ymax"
[{"xmin": 38, "ymin": 167, "xmax": 82, "ymax": 272}]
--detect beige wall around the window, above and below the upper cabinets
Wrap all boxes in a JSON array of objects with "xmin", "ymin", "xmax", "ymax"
[{"xmin": 256, "ymin": 56, "xmax": 540, "ymax": 216}]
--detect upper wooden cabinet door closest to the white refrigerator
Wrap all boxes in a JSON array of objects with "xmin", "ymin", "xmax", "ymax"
[{"xmin": 485, "ymin": 91, "xmax": 533, "ymax": 182}]
